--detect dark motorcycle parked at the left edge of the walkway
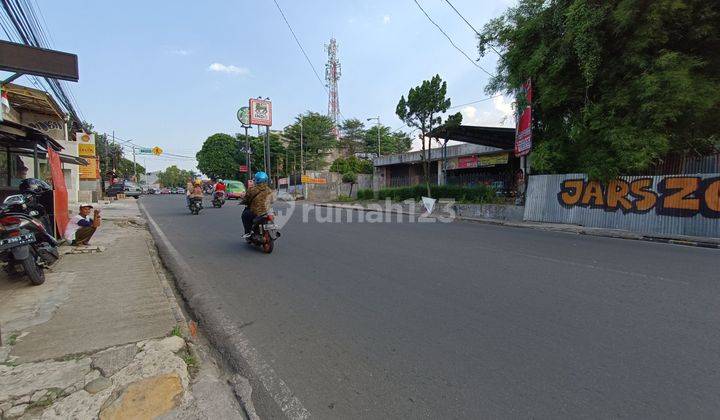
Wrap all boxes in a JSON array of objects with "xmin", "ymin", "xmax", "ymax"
[{"xmin": 0, "ymin": 195, "xmax": 60, "ymax": 285}]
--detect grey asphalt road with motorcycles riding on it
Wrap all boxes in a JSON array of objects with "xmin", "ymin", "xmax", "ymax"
[{"xmin": 142, "ymin": 196, "xmax": 720, "ymax": 418}]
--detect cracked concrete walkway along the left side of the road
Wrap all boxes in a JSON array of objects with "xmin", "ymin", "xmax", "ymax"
[{"xmin": 0, "ymin": 199, "xmax": 244, "ymax": 419}]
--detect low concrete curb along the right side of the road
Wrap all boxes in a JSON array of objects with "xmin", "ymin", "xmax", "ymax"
[{"xmin": 312, "ymin": 203, "xmax": 720, "ymax": 249}]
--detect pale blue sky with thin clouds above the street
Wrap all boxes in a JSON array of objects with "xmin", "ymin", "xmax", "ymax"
[{"xmin": 26, "ymin": 0, "xmax": 513, "ymax": 170}]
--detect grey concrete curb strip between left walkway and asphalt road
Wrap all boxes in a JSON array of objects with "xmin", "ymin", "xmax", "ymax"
[{"xmin": 139, "ymin": 203, "xmax": 310, "ymax": 419}]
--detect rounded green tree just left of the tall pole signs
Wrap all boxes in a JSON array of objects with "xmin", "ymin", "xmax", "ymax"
[{"xmin": 195, "ymin": 133, "xmax": 239, "ymax": 178}]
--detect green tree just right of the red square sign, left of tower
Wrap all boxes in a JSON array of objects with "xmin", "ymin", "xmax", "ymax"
[{"xmin": 284, "ymin": 111, "xmax": 337, "ymax": 170}]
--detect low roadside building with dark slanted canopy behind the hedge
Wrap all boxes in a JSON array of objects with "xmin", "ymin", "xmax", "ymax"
[{"xmin": 373, "ymin": 125, "xmax": 520, "ymax": 193}]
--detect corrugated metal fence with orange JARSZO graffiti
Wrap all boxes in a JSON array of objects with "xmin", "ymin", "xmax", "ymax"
[{"xmin": 525, "ymin": 173, "xmax": 720, "ymax": 237}]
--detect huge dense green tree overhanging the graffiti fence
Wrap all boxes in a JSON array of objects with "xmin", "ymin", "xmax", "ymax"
[{"xmin": 479, "ymin": 0, "xmax": 720, "ymax": 179}]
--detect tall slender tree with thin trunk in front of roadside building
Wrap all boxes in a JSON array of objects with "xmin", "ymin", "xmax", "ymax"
[{"xmin": 395, "ymin": 75, "xmax": 462, "ymax": 197}]
